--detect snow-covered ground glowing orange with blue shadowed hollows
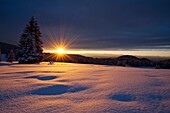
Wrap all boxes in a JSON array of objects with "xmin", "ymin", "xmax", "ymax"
[{"xmin": 0, "ymin": 63, "xmax": 170, "ymax": 113}]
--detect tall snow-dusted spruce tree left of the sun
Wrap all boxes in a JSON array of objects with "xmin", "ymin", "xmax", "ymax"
[{"xmin": 18, "ymin": 17, "xmax": 43, "ymax": 64}]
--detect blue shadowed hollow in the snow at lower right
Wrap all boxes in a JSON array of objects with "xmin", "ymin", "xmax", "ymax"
[{"xmin": 111, "ymin": 94, "xmax": 134, "ymax": 102}]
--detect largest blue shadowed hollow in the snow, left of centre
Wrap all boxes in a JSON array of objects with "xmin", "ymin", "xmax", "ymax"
[{"xmin": 31, "ymin": 85, "xmax": 87, "ymax": 95}]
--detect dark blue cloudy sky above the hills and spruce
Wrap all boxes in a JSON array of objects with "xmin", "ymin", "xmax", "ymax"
[{"xmin": 0, "ymin": 0, "xmax": 170, "ymax": 56}]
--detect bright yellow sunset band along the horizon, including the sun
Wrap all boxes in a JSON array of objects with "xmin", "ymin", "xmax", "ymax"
[{"xmin": 44, "ymin": 48, "xmax": 170, "ymax": 57}]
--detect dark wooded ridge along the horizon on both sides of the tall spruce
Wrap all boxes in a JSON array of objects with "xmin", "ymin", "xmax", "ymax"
[{"xmin": 0, "ymin": 42, "xmax": 170, "ymax": 69}]
